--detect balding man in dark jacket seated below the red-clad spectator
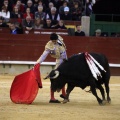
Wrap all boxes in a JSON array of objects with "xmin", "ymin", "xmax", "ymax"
[{"xmin": 22, "ymin": 16, "xmax": 34, "ymax": 31}]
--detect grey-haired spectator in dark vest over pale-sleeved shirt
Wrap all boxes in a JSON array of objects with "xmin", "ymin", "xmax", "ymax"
[{"xmin": 46, "ymin": 7, "xmax": 60, "ymax": 25}]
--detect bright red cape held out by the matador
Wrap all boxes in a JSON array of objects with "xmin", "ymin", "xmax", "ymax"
[{"xmin": 10, "ymin": 64, "xmax": 42, "ymax": 104}]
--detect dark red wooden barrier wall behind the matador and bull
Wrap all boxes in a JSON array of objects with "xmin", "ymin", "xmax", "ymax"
[{"xmin": 0, "ymin": 34, "xmax": 120, "ymax": 75}]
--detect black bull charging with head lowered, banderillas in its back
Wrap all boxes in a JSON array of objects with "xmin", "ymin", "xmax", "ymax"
[{"xmin": 46, "ymin": 53, "xmax": 111, "ymax": 105}]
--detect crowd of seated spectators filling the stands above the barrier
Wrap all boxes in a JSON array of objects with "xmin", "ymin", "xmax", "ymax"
[{"xmin": 0, "ymin": 0, "xmax": 95, "ymax": 36}]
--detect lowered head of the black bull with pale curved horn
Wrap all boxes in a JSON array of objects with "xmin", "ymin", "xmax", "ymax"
[{"xmin": 44, "ymin": 70, "xmax": 65, "ymax": 92}]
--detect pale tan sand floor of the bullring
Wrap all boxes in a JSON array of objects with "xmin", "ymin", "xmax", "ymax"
[{"xmin": 0, "ymin": 75, "xmax": 120, "ymax": 120}]
